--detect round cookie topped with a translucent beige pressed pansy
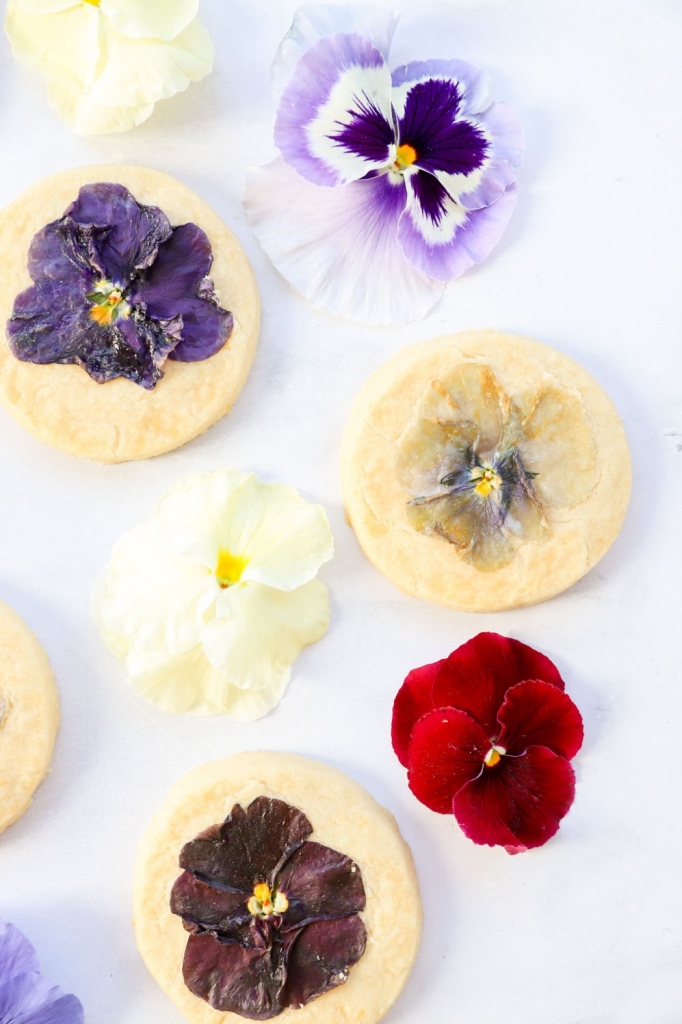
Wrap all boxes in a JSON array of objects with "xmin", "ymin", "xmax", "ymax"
[{"xmin": 341, "ymin": 331, "xmax": 631, "ymax": 611}]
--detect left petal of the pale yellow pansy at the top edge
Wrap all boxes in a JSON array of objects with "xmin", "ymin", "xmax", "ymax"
[{"xmin": 5, "ymin": 0, "xmax": 99, "ymax": 89}]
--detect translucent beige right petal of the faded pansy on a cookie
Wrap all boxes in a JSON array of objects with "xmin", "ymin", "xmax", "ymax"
[{"xmin": 521, "ymin": 384, "xmax": 598, "ymax": 508}]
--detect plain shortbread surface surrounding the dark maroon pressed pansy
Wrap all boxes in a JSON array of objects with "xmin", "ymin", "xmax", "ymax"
[{"xmin": 134, "ymin": 752, "xmax": 422, "ymax": 1024}]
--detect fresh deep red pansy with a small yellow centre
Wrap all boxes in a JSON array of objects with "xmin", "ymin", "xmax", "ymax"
[{"xmin": 391, "ymin": 633, "xmax": 583, "ymax": 853}]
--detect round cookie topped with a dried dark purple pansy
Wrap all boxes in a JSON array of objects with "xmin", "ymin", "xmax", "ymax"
[{"xmin": 0, "ymin": 165, "xmax": 260, "ymax": 462}]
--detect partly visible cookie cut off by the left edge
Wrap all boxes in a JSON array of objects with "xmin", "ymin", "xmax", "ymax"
[{"xmin": 0, "ymin": 602, "xmax": 59, "ymax": 833}]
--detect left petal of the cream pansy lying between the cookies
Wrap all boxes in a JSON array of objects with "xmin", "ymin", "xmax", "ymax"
[{"xmin": 92, "ymin": 523, "xmax": 216, "ymax": 653}]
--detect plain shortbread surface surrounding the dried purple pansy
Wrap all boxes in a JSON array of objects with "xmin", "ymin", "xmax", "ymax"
[{"xmin": 0, "ymin": 165, "xmax": 260, "ymax": 463}]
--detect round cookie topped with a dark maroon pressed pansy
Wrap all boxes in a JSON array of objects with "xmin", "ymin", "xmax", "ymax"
[{"xmin": 134, "ymin": 752, "xmax": 421, "ymax": 1024}]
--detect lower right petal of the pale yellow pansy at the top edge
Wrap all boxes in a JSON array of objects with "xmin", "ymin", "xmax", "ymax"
[{"xmin": 92, "ymin": 22, "xmax": 213, "ymax": 108}]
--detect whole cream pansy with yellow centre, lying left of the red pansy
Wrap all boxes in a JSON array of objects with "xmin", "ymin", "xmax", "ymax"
[{"xmin": 92, "ymin": 469, "xmax": 334, "ymax": 721}]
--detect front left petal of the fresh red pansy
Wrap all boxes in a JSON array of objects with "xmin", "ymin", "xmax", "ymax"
[{"xmin": 408, "ymin": 708, "xmax": 491, "ymax": 814}]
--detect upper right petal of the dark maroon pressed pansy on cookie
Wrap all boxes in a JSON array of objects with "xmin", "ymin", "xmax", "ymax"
[{"xmin": 276, "ymin": 842, "xmax": 366, "ymax": 931}]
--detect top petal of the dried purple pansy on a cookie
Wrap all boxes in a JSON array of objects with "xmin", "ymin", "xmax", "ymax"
[{"xmin": 66, "ymin": 182, "xmax": 172, "ymax": 285}]
